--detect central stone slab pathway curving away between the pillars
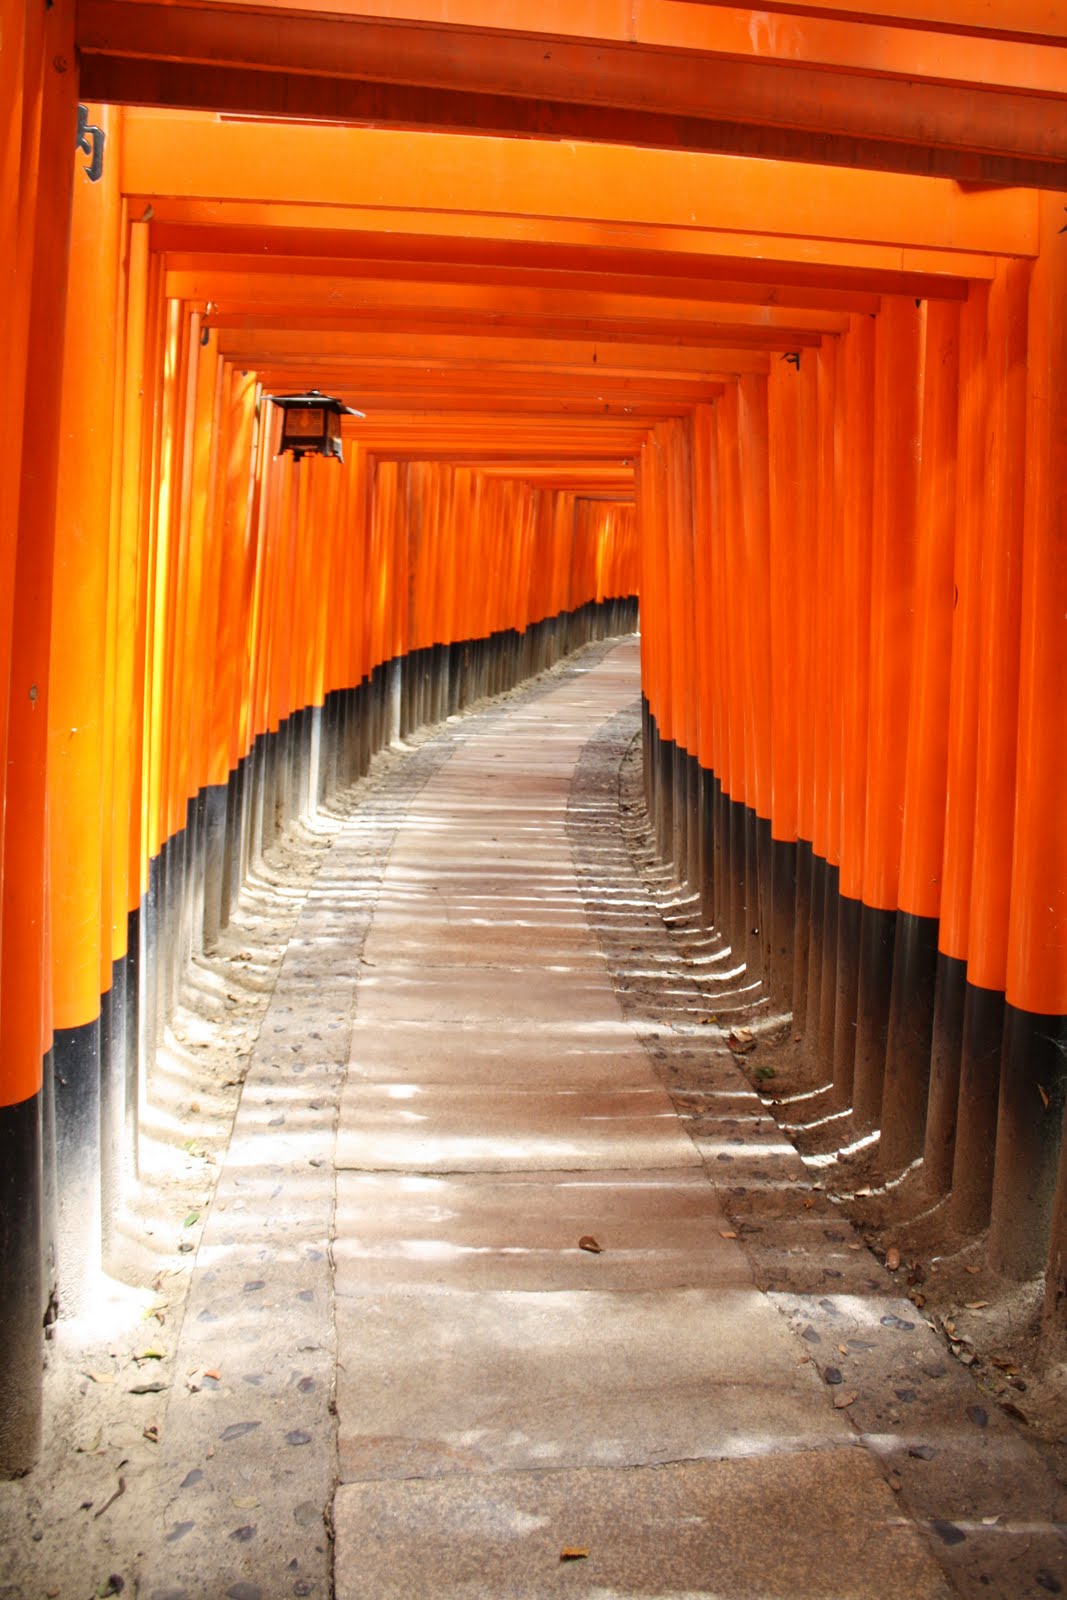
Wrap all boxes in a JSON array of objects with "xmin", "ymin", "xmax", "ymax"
[{"xmin": 333, "ymin": 643, "xmax": 952, "ymax": 1600}]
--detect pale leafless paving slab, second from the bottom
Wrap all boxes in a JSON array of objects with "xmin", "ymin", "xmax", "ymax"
[{"xmin": 336, "ymin": 1290, "xmax": 848, "ymax": 1482}]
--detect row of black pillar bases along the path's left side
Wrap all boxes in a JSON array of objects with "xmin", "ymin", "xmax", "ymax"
[{"xmin": 0, "ymin": 600, "xmax": 637, "ymax": 1475}]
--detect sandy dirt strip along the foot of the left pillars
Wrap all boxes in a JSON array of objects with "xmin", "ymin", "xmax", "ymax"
[{"xmin": 0, "ymin": 803, "xmax": 344, "ymax": 1600}]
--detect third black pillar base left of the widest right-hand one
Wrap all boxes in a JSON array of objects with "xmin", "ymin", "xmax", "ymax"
[{"xmin": 878, "ymin": 912, "xmax": 937, "ymax": 1174}]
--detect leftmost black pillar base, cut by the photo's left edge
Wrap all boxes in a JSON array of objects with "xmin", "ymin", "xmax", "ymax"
[{"xmin": 0, "ymin": 1094, "xmax": 45, "ymax": 1478}]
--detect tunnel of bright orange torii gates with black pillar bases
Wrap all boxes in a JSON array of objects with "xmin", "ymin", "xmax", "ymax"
[{"xmin": 0, "ymin": 0, "xmax": 1067, "ymax": 1472}]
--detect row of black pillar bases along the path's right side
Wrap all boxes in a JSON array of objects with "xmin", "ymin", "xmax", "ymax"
[{"xmin": 643, "ymin": 706, "xmax": 1067, "ymax": 1354}]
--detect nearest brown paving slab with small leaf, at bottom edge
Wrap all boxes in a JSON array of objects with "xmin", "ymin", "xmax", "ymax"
[{"xmin": 334, "ymin": 1446, "xmax": 952, "ymax": 1600}]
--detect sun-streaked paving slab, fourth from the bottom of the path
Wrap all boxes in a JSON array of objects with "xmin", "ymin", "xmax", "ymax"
[{"xmin": 336, "ymin": 1082, "xmax": 699, "ymax": 1173}]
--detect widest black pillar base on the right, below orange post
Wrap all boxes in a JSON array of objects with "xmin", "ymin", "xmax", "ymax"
[{"xmin": 989, "ymin": 1005, "xmax": 1067, "ymax": 1278}]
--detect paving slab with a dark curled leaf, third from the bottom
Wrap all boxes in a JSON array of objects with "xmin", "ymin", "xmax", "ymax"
[{"xmin": 334, "ymin": 1171, "xmax": 752, "ymax": 1294}]
